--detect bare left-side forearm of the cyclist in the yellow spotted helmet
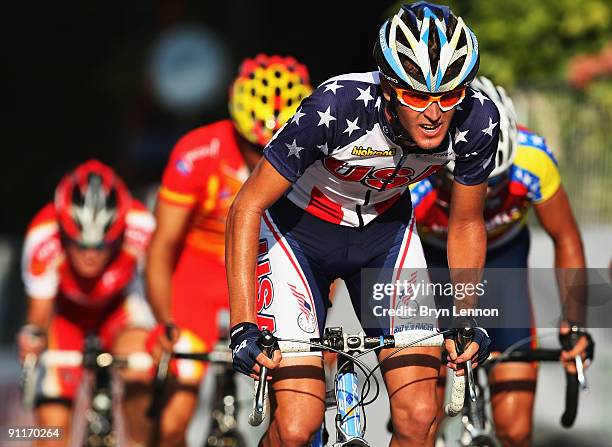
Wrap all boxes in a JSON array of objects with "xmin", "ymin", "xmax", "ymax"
[{"xmin": 145, "ymin": 241, "xmax": 177, "ymax": 323}]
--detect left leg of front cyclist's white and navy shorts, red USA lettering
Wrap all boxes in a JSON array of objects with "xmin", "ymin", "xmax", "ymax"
[{"xmin": 257, "ymin": 203, "xmax": 338, "ymax": 350}]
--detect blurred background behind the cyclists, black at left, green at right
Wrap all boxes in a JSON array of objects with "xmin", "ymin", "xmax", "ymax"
[{"xmin": 0, "ymin": 0, "xmax": 612, "ymax": 445}]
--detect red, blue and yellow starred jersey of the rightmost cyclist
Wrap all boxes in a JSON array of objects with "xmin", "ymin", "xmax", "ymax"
[{"xmin": 410, "ymin": 127, "xmax": 561, "ymax": 250}]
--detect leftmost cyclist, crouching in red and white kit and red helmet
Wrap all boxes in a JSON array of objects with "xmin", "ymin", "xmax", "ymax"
[{"xmin": 17, "ymin": 160, "xmax": 155, "ymax": 445}]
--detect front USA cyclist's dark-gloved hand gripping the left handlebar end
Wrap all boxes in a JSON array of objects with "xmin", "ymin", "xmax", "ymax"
[{"xmin": 230, "ymin": 322, "xmax": 281, "ymax": 379}]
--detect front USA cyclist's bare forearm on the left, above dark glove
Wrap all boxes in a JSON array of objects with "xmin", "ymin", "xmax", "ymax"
[{"xmin": 225, "ymin": 200, "xmax": 261, "ymax": 326}]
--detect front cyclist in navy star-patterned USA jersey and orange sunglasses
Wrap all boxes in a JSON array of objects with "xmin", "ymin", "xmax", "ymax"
[{"xmin": 226, "ymin": 2, "xmax": 499, "ymax": 446}]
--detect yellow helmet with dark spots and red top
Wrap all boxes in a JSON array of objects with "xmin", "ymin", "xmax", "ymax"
[{"xmin": 229, "ymin": 54, "xmax": 312, "ymax": 146}]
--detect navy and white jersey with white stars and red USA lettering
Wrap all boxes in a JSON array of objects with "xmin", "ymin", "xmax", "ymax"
[{"xmin": 264, "ymin": 72, "xmax": 499, "ymax": 227}]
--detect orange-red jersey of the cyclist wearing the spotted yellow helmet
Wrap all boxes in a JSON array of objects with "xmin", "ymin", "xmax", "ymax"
[{"xmin": 159, "ymin": 120, "xmax": 248, "ymax": 262}]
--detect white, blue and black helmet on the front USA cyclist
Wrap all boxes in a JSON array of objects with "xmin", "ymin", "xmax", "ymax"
[{"xmin": 374, "ymin": 2, "xmax": 480, "ymax": 93}]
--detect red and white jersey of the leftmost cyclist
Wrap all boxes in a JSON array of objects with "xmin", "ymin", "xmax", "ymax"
[{"xmin": 22, "ymin": 200, "xmax": 155, "ymax": 308}]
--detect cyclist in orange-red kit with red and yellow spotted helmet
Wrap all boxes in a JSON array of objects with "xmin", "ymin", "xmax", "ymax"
[{"xmin": 146, "ymin": 54, "xmax": 312, "ymax": 446}]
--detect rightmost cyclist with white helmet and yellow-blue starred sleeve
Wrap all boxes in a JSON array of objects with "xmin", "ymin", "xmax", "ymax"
[{"xmin": 411, "ymin": 77, "xmax": 588, "ymax": 446}]
